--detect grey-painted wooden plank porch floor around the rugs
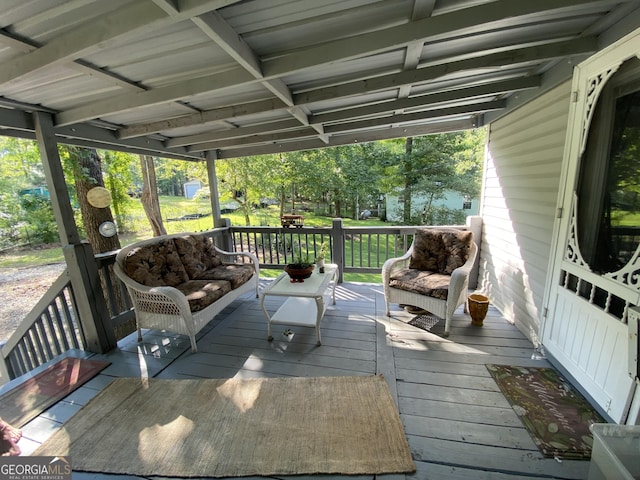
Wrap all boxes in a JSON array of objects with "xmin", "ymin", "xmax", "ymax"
[{"xmin": 12, "ymin": 284, "xmax": 589, "ymax": 480}]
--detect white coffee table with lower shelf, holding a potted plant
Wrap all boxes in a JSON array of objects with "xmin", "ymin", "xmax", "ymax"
[{"xmin": 260, "ymin": 263, "xmax": 338, "ymax": 345}]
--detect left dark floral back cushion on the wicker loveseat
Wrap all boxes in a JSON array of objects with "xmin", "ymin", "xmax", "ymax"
[{"xmin": 124, "ymin": 239, "xmax": 189, "ymax": 287}]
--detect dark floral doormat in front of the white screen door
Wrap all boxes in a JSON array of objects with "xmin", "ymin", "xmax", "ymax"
[{"xmin": 486, "ymin": 365, "xmax": 606, "ymax": 460}]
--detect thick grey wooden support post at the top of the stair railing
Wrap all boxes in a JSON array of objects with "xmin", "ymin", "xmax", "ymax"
[{"xmin": 33, "ymin": 112, "xmax": 116, "ymax": 353}]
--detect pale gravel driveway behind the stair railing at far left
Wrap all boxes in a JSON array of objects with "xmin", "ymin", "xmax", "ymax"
[{"xmin": 0, "ymin": 263, "xmax": 66, "ymax": 342}]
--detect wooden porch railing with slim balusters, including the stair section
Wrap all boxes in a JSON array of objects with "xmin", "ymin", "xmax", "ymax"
[{"xmin": 0, "ymin": 219, "xmax": 480, "ymax": 384}]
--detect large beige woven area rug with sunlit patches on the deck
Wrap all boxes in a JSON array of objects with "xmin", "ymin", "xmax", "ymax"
[{"xmin": 34, "ymin": 376, "xmax": 415, "ymax": 477}]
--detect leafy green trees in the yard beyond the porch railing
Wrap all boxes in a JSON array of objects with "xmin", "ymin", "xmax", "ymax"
[{"xmin": 0, "ymin": 130, "xmax": 484, "ymax": 248}]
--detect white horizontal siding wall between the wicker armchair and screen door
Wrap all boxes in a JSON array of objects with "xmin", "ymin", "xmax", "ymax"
[{"xmin": 478, "ymin": 82, "xmax": 571, "ymax": 345}]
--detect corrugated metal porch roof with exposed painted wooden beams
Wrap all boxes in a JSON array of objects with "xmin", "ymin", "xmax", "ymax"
[{"xmin": 0, "ymin": 0, "xmax": 640, "ymax": 160}]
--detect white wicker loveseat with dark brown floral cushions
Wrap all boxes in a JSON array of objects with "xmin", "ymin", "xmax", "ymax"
[{"xmin": 114, "ymin": 233, "xmax": 260, "ymax": 352}]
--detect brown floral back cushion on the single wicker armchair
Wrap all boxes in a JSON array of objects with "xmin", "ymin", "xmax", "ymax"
[{"xmin": 409, "ymin": 228, "xmax": 473, "ymax": 275}]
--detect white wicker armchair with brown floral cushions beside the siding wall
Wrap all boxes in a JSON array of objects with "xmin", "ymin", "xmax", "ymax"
[{"xmin": 382, "ymin": 228, "xmax": 478, "ymax": 336}]
